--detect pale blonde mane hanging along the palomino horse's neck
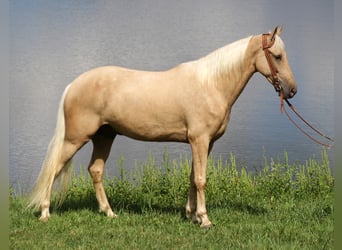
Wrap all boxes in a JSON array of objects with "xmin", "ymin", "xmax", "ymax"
[{"xmin": 196, "ymin": 36, "xmax": 251, "ymax": 85}]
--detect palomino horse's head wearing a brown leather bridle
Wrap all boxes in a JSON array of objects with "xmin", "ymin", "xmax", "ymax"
[{"xmin": 256, "ymin": 26, "xmax": 297, "ymax": 98}]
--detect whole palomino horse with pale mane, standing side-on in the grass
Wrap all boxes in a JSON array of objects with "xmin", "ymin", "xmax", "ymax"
[{"xmin": 29, "ymin": 27, "xmax": 296, "ymax": 227}]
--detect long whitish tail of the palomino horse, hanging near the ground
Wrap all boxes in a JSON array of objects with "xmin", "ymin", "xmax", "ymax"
[{"xmin": 28, "ymin": 85, "xmax": 71, "ymax": 209}]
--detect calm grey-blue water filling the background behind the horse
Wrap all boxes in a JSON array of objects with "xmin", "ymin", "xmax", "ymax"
[{"xmin": 10, "ymin": 0, "xmax": 334, "ymax": 188}]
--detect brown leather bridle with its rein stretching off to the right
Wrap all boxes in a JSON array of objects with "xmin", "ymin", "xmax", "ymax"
[{"xmin": 262, "ymin": 34, "xmax": 334, "ymax": 148}]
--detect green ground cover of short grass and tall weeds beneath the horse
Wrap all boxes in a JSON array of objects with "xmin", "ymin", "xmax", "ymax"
[{"xmin": 10, "ymin": 151, "xmax": 334, "ymax": 249}]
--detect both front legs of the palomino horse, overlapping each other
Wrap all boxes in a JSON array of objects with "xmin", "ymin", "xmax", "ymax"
[{"xmin": 186, "ymin": 138, "xmax": 212, "ymax": 228}]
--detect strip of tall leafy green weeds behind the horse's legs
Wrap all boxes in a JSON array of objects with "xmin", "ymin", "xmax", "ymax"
[{"xmin": 58, "ymin": 151, "xmax": 334, "ymax": 212}]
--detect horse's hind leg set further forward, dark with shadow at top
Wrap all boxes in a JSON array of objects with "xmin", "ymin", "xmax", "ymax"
[{"xmin": 88, "ymin": 125, "xmax": 117, "ymax": 218}]
